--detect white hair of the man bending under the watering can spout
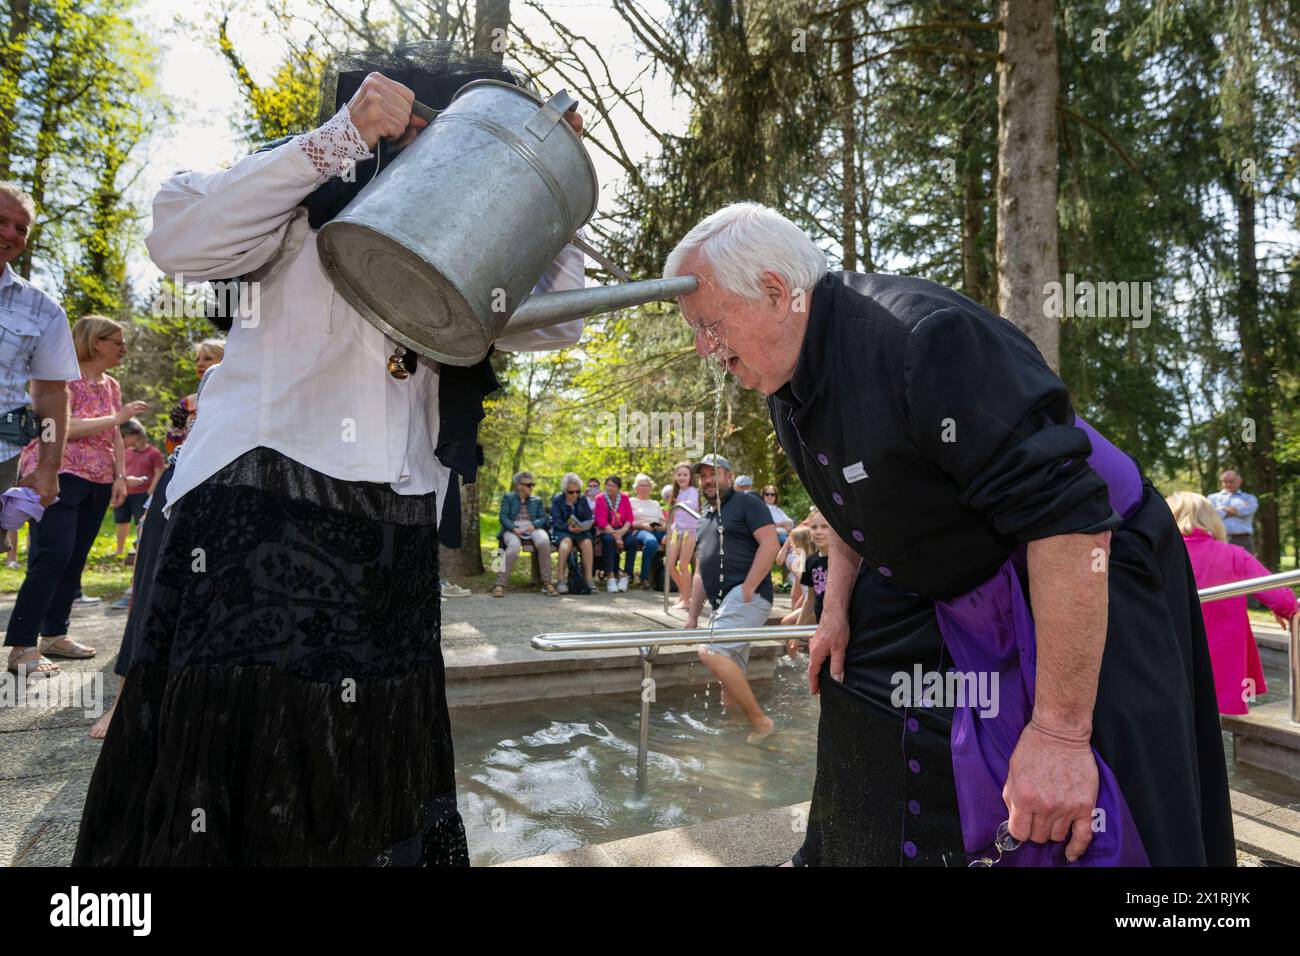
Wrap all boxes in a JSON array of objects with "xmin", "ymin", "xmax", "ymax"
[{"xmin": 663, "ymin": 203, "xmax": 827, "ymax": 299}]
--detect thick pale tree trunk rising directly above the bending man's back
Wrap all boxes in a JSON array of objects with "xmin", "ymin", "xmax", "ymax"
[{"xmin": 997, "ymin": 0, "xmax": 1061, "ymax": 369}]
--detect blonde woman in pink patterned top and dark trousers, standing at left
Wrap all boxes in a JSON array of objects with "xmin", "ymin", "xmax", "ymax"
[{"xmin": 4, "ymin": 315, "xmax": 148, "ymax": 678}]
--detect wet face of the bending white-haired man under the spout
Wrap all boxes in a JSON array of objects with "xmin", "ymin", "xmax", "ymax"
[{"xmin": 677, "ymin": 256, "xmax": 807, "ymax": 395}]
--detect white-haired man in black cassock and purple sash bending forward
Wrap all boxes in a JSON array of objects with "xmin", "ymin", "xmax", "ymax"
[{"xmin": 664, "ymin": 203, "xmax": 1235, "ymax": 866}]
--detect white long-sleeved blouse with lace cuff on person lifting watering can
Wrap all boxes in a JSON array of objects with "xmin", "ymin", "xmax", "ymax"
[{"xmin": 146, "ymin": 107, "xmax": 584, "ymax": 512}]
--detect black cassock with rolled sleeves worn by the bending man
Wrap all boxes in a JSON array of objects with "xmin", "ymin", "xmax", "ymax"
[{"xmin": 768, "ymin": 273, "xmax": 1235, "ymax": 866}]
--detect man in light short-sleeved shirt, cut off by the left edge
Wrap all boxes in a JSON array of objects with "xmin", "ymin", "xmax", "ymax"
[{"xmin": 0, "ymin": 182, "xmax": 81, "ymax": 506}]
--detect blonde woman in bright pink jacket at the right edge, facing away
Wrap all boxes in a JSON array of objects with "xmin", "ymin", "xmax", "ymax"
[{"xmin": 1165, "ymin": 492, "xmax": 1296, "ymax": 714}]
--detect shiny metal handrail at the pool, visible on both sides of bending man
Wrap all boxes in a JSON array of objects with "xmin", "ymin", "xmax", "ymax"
[{"xmin": 529, "ymin": 567, "xmax": 1300, "ymax": 796}]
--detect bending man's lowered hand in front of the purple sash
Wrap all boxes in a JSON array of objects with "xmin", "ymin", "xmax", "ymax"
[{"xmin": 1002, "ymin": 721, "xmax": 1097, "ymax": 862}]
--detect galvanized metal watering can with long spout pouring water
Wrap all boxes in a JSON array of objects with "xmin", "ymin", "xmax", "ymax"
[{"xmin": 317, "ymin": 79, "xmax": 697, "ymax": 365}]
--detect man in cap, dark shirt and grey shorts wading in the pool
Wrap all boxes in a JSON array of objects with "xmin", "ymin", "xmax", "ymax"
[{"xmin": 686, "ymin": 455, "xmax": 780, "ymax": 744}]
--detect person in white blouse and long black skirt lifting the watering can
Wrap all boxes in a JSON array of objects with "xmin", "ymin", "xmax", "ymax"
[{"xmin": 74, "ymin": 49, "xmax": 582, "ymax": 865}]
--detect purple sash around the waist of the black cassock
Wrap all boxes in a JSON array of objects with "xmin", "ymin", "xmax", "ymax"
[{"xmin": 935, "ymin": 418, "xmax": 1149, "ymax": 866}]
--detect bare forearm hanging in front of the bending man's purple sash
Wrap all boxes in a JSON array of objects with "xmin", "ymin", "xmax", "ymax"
[{"xmin": 1028, "ymin": 531, "xmax": 1110, "ymax": 737}]
